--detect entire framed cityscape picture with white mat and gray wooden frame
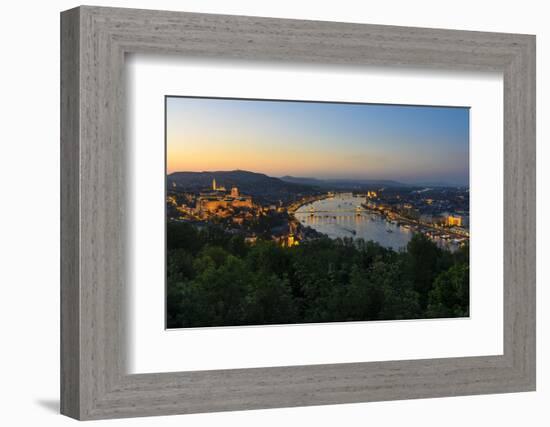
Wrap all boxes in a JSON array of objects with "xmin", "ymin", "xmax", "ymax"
[{"xmin": 61, "ymin": 6, "xmax": 536, "ymax": 420}]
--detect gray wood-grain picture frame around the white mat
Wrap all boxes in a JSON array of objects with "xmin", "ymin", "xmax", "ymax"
[{"xmin": 61, "ymin": 6, "xmax": 535, "ymax": 419}]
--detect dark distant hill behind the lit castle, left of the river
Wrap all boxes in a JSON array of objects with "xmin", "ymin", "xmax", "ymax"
[{"xmin": 167, "ymin": 170, "xmax": 320, "ymax": 203}]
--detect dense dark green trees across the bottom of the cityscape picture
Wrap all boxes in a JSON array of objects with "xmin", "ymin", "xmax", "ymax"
[{"xmin": 167, "ymin": 222, "xmax": 469, "ymax": 328}]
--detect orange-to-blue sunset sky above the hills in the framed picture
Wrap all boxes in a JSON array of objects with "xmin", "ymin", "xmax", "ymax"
[{"xmin": 166, "ymin": 97, "xmax": 469, "ymax": 185}]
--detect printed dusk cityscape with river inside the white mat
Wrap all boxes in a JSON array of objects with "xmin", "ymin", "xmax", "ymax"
[{"xmin": 165, "ymin": 96, "xmax": 470, "ymax": 329}]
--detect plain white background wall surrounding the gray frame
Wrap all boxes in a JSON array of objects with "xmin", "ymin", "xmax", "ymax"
[{"xmin": 0, "ymin": 0, "xmax": 550, "ymax": 427}]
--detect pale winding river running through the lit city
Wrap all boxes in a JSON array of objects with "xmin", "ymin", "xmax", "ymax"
[{"xmin": 295, "ymin": 193, "xmax": 413, "ymax": 250}]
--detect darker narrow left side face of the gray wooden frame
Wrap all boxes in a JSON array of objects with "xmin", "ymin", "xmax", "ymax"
[{"xmin": 60, "ymin": 10, "xmax": 80, "ymax": 417}]
